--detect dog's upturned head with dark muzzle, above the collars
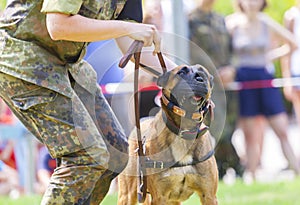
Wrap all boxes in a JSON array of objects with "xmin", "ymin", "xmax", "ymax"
[{"xmin": 157, "ymin": 65, "xmax": 213, "ymax": 120}]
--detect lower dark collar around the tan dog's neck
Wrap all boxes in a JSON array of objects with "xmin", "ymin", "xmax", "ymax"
[{"xmin": 162, "ymin": 112, "xmax": 208, "ymax": 140}]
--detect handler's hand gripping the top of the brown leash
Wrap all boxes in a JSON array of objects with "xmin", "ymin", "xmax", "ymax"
[{"xmin": 128, "ymin": 23, "xmax": 161, "ymax": 54}]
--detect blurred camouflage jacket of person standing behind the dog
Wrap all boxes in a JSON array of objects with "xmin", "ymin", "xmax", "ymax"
[{"xmin": 189, "ymin": 9, "xmax": 231, "ymax": 68}]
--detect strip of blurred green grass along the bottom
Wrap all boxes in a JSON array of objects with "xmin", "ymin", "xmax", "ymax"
[{"xmin": 0, "ymin": 177, "xmax": 300, "ymax": 205}]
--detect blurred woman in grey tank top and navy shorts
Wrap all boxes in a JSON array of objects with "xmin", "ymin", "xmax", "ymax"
[{"xmin": 226, "ymin": 0, "xmax": 299, "ymax": 183}]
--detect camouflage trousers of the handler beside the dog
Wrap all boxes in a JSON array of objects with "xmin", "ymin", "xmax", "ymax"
[{"xmin": 0, "ymin": 73, "xmax": 128, "ymax": 205}]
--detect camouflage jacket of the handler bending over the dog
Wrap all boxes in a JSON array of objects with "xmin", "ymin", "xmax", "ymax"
[{"xmin": 0, "ymin": 0, "xmax": 127, "ymax": 97}]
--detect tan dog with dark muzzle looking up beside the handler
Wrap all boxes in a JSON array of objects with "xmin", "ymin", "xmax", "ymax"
[{"xmin": 118, "ymin": 65, "xmax": 218, "ymax": 205}]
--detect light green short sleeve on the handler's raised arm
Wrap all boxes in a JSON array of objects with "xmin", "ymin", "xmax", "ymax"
[{"xmin": 41, "ymin": 0, "xmax": 83, "ymax": 14}]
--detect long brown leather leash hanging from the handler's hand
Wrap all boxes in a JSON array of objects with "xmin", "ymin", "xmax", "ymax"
[{"xmin": 119, "ymin": 41, "xmax": 167, "ymax": 203}]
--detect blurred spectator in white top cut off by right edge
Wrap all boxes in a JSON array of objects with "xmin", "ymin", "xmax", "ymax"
[{"xmin": 281, "ymin": 0, "xmax": 300, "ymax": 135}]
